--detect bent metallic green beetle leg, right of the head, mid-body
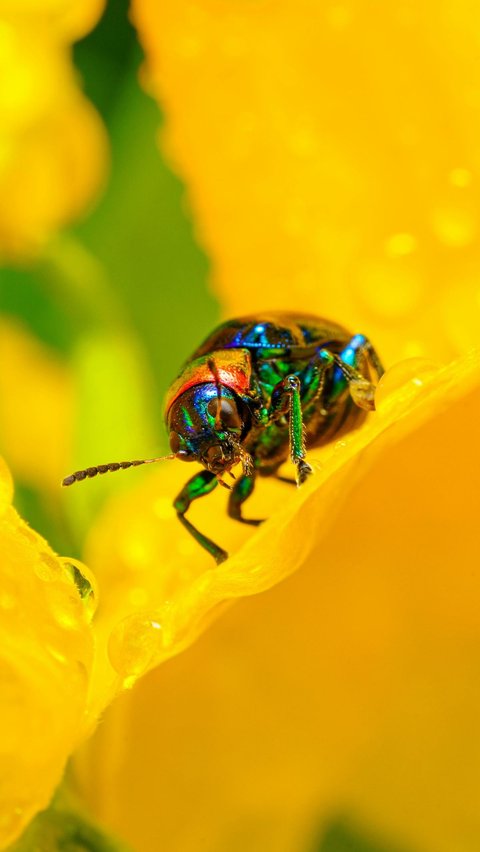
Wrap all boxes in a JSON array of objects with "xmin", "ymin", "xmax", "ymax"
[{"xmin": 269, "ymin": 375, "xmax": 313, "ymax": 485}]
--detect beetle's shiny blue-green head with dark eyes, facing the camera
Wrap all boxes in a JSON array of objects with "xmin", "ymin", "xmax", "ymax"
[{"xmin": 167, "ymin": 383, "xmax": 250, "ymax": 476}]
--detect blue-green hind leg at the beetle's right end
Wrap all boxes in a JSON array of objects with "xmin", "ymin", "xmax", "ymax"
[{"xmin": 318, "ymin": 334, "xmax": 384, "ymax": 411}]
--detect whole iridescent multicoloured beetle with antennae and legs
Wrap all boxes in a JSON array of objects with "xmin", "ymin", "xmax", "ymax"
[{"xmin": 63, "ymin": 312, "xmax": 383, "ymax": 563}]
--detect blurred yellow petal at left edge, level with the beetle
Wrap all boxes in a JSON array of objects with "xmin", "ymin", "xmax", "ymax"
[{"xmin": 0, "ymin": 319, "xmax": 73, "ymax": 497}]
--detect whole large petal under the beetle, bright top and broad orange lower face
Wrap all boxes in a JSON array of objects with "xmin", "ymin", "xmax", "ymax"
[{"xmin": 79, "ymin": 355, "xmax": 480, "ymax": 852}]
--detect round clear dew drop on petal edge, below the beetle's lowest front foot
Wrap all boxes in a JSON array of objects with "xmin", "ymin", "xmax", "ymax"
[{"xmin": 108, "ymin": 613, "xmax": 164, "ymax": 678}]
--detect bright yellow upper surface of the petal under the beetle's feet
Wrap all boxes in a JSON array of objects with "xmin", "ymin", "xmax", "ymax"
[{"xmin": 81, "ymin": 358, "xmax": 478, "ymax": 678}]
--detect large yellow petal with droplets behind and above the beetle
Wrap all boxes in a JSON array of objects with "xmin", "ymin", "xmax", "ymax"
[{"xmin": 132, "ymin": 0, "xmax": 480, "ymax": 363}]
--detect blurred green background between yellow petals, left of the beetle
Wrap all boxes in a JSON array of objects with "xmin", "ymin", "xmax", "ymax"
[{"xmin": 0, "ymin": 0, "xmax": 219, "ymax": 556}]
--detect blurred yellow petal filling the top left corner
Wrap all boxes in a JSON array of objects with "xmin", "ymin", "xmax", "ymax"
[{"xmin": 0, "ymin": 5, "xmax": 108, "ymax": 260}]
